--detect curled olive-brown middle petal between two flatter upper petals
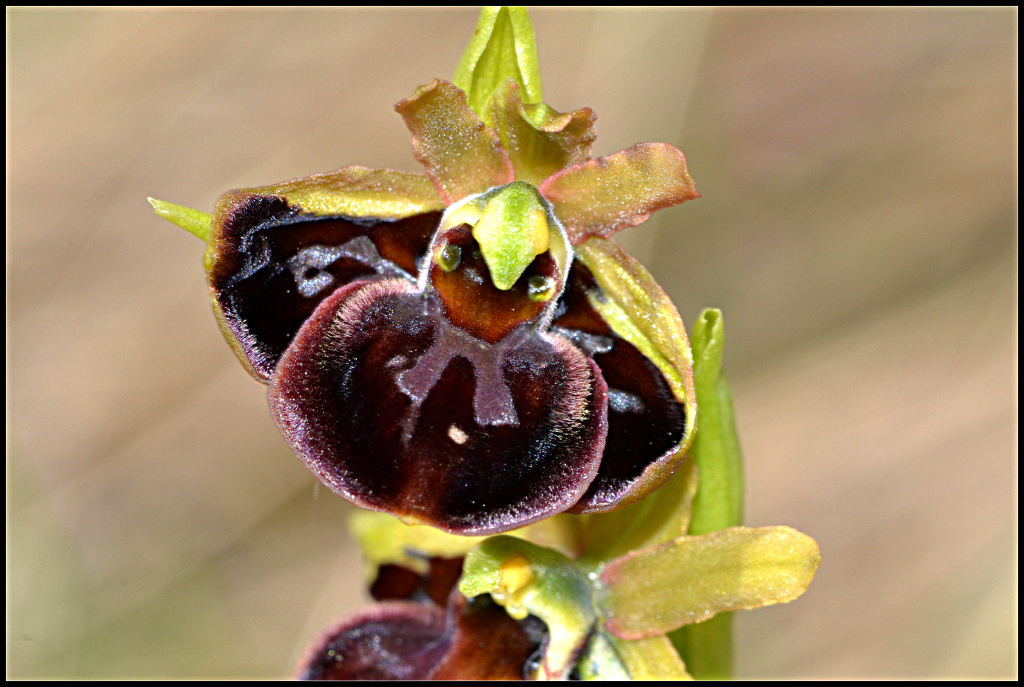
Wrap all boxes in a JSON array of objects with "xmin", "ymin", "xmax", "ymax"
[{"xmin": 484, "ymin": 79, "xmax": 597, "ymax": 186}]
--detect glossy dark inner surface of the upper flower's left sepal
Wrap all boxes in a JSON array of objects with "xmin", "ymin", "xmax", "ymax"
[{"xmin": 208, "ymin": 196, "xmax": 440, "ymax": 380}]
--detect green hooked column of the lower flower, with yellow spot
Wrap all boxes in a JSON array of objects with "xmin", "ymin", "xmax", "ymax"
[{"xmin": 459, "ymin": 534, "xmax": 596, "ymax": 679}]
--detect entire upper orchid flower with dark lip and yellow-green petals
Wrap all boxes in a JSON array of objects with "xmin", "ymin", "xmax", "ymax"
[{"xmin": 199, "ymin": 81, "xmax": 696, "ymax": 534}]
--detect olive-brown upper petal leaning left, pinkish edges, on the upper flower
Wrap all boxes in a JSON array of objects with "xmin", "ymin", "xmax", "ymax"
[{"xmin": 394, "ymin": 79, "xmax": 515, "ymax": 205}]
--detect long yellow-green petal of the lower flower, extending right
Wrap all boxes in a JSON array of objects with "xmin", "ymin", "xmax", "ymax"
[{"xmin": 598, "ymin": 527, "xmax": 821, "ymax": 639}]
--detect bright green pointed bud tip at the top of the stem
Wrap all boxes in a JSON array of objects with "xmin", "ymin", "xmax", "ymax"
[{"xmin": 454, "ymin": 7, "xmax": 544, "ymax": 122}]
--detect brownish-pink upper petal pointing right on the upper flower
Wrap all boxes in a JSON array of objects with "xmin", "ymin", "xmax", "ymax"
[{"xmin": 541, "ymin": 143, "xmax": 700, "ymax": 244}]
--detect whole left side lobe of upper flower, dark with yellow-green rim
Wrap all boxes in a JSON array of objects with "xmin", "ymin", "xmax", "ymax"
[{"xmin": 206, "ymin": 167, "xmax": 443, "ymax": 381}]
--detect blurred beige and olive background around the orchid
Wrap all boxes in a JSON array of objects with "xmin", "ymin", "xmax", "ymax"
[{"xmin": 6, "ymin": 9, "xmax": 1018, "ymax": 678}]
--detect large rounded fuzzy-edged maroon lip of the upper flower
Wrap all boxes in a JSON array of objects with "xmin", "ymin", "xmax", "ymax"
[{"xmin": 269, "ymin": 280, "xmax": 607, "ymax": 534}]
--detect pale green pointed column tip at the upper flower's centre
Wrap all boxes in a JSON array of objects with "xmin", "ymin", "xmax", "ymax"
[{"xmin": 473, "ymin": 181, "xmax": 551, "ymax": 291}]
